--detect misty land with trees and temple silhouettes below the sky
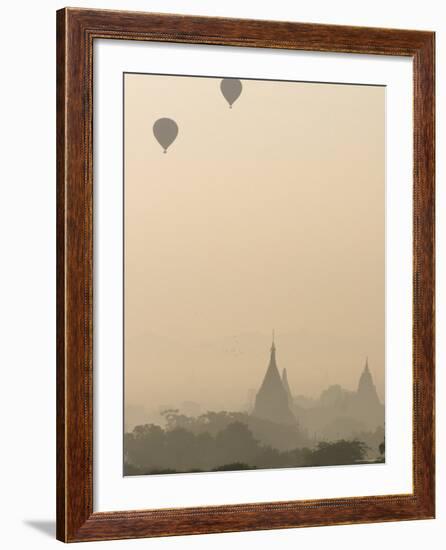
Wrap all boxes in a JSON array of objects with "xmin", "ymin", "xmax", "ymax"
[{"xmin": 124, "ymin": 341, "xmax": 385, "ymax": 475}]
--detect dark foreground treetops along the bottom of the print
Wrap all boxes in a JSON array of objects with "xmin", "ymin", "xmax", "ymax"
[{"xmin": 125, "ymin": 411, "xmax": 367, "ymax": 475}]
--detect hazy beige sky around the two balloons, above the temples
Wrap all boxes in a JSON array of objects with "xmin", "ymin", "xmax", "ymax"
[{"xmin": 125, "ymin": 75, "xmax": 385, "ymax": 418}]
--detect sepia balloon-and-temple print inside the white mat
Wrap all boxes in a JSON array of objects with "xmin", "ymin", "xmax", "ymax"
[{"xmin": 124, "ymin": 74, "xmax": 385, "ymax": 475}]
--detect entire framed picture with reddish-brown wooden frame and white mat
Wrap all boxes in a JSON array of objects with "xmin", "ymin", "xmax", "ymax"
[{"xmin": 57, "ymin": 8, "xmax": 435, "ymax": 542}]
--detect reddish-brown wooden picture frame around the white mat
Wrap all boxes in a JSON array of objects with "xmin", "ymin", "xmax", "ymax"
[{"xmin": 57, "ymin": 8, "xmax": 435, "ymax": 542}]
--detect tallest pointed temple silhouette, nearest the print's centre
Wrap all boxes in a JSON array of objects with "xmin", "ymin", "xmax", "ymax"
[{"xmin": 252, "ymin": 337, "xmax": 296, "ymax": 424}]
